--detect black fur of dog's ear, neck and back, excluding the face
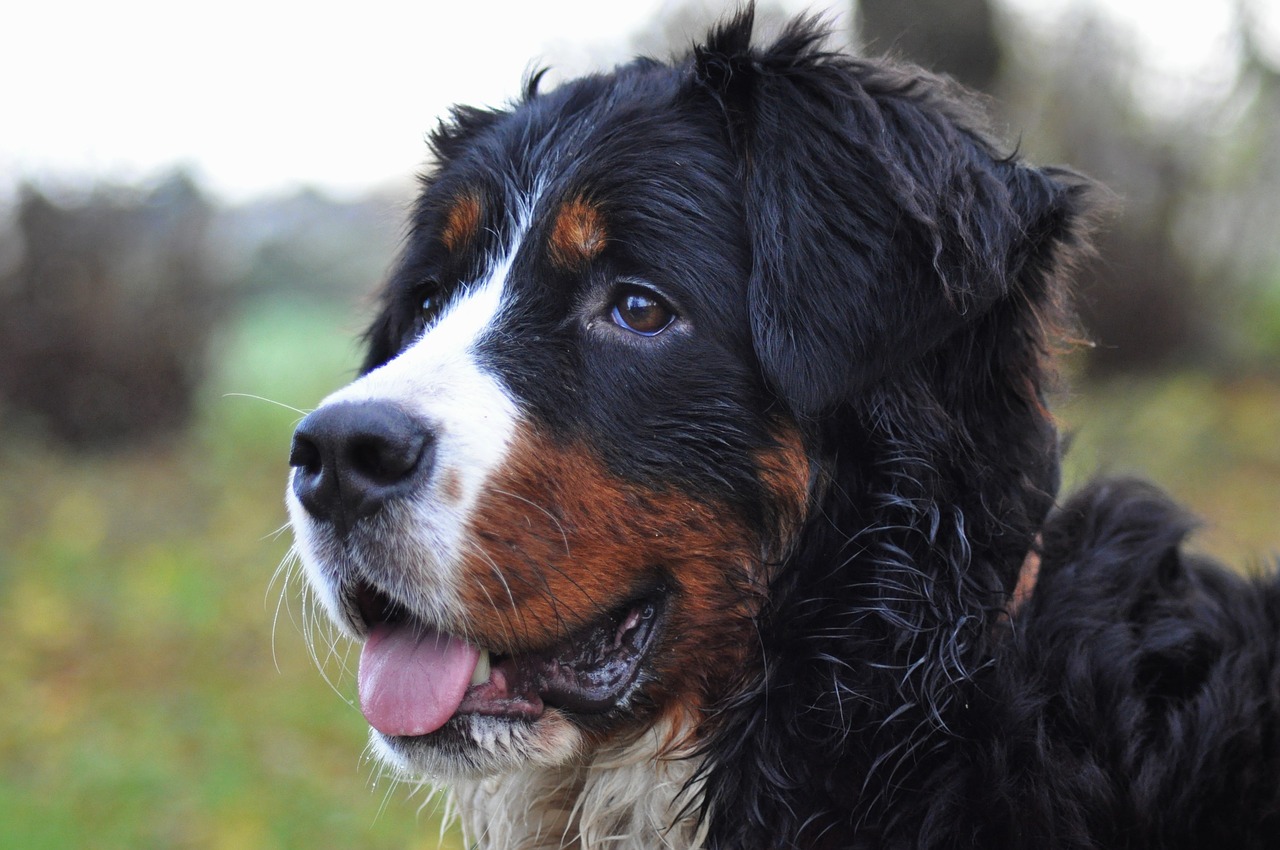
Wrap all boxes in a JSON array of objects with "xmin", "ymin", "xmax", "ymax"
[{"xmin": 698, "ymin": 8, "xmax": 1280, "ymax": 849}]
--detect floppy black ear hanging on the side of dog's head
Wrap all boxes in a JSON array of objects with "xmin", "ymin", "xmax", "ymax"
[{"xmin": 694, "ymin": 10, "xmax": 1078, "ymax": 416}]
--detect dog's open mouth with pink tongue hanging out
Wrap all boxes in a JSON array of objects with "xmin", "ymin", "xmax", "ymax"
[{"xmin": 357, "ymin": 586, "xmax": 663, "ymax": 737}]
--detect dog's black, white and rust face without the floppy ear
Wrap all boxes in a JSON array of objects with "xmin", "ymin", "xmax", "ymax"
[{"xmin": 288, "ymin": 59, "xmax": 809, "ymax": 774}]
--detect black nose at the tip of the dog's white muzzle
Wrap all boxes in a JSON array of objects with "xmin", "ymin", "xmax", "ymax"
[{"xmin": 289, "ymin": 402, "xmax": 435, "ymax": 536}]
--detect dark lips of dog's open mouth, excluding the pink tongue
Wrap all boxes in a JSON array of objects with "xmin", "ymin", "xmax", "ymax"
[{"xmin": 353, "ymin": 584, "xmax": 667, "ymax": 737}]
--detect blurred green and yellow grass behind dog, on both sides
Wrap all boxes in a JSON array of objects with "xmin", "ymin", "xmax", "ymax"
[{"xmin": 0, "ymin": 301, "xmax": 1280, "ymax": 849}]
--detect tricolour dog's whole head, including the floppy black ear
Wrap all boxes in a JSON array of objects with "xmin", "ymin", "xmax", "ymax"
[{"xmin": 288, "ymin": 14, "xmax": 1076, "ymax": 803}]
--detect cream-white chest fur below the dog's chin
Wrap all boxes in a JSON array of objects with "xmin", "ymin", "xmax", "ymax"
[{"xmin": 452, "ymin": 727, "xmax": 705, "ymax": 850}]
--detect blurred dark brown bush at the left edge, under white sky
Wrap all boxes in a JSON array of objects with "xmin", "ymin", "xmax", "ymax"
[{"xmin": 0, "ymin": 173, "xmax": 225, "ymax": 448}]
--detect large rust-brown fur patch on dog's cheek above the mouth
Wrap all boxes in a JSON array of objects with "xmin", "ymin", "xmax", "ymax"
[{"xmin": 462, "ymin": 433, "xmax": 765, "ymax": 710}]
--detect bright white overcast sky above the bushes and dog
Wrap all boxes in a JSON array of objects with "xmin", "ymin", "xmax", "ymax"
[{"xmin": 0, "ymin": 0, "xmax": 1280, "ymax": 200}]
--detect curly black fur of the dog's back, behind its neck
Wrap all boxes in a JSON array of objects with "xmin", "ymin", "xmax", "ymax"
[{"xmin": 970, "ymin": 479, "xmax": 1280, "ymax": 847}]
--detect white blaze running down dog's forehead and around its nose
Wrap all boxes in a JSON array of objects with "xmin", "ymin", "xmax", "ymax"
[{"xmin": 287, "ymin": 216, "xmax": 527, "ymax": 625}]
